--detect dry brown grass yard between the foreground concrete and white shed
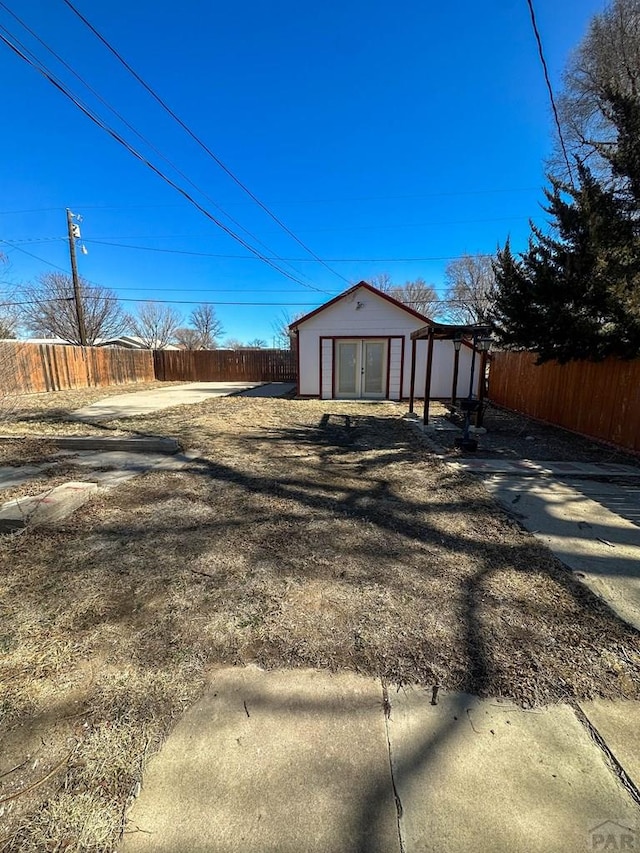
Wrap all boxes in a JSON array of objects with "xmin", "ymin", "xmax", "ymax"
[{"xmin": 0, "ymin": 397, "xmax": 640, "ymax": 853}]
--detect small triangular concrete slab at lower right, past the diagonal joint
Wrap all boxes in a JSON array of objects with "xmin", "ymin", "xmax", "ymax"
[{"xmin": 579, "ymin": 699, "xmax": 640, "ymax": 789}]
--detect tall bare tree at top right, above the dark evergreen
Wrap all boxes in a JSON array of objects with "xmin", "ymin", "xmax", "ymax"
[{"xmin": 551, "ymin": 0, "xmax": 640, "ymax": 177}]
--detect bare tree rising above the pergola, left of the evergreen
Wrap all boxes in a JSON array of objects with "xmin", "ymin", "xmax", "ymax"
[{"xmin": 444, "ymin": 255, "xmax": 496, "ymax": 324}]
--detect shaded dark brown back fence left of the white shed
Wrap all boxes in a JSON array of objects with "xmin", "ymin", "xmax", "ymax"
[{"xmin": 153, "ymin": 349, "xmax": 298, "ymax": 382}]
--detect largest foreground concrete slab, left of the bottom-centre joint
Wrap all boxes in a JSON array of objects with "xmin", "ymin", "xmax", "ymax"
[{"xmin": 123, "ymin": 667, "xmax": 400, "ymax": 853}]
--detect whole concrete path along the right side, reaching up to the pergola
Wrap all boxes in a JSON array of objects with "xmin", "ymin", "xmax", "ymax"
[{"xmin": 405, "ymin": 418, "xmax": 640, "ymax": 632}]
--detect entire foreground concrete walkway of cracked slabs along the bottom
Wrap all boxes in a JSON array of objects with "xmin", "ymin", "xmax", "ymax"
[{"xmin": 123, "ymin": 667, "xmax": 640, "ymax": 853}]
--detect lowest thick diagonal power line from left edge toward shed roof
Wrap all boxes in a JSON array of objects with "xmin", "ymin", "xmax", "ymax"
[{"xmin": 0, "ymin": 27, "xmax": 326, "ymax": 293}]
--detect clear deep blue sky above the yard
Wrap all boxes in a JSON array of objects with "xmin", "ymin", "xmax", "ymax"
[{"xmin": 0, "ymin": 0, "xmax": 604, "ymax": 342}]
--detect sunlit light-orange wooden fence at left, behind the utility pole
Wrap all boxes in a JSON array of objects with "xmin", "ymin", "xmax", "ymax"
[{"xmin": 0, "ymin": 341, "xmax": 155, "ymax": 395}]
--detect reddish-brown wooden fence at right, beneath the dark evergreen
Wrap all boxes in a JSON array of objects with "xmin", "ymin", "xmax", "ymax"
[{"xmin": 489, "ymin": 352, "xmax": 640, "ymax": 452}]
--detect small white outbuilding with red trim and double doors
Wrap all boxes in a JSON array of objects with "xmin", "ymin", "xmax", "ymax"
[{"xmin": 290, "ymin": 281, "xmax": 477, "ymax": 400}]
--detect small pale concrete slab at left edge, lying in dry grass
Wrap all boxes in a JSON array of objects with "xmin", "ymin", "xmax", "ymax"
[{"xmin": 0, "ymin": 482, "xmax": 98, "ymax": 533}]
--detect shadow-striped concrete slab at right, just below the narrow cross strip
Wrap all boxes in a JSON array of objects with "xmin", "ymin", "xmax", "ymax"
[{"xmin": 484, "ymin": 475, "xmax": 640, "ymax": 631}]
